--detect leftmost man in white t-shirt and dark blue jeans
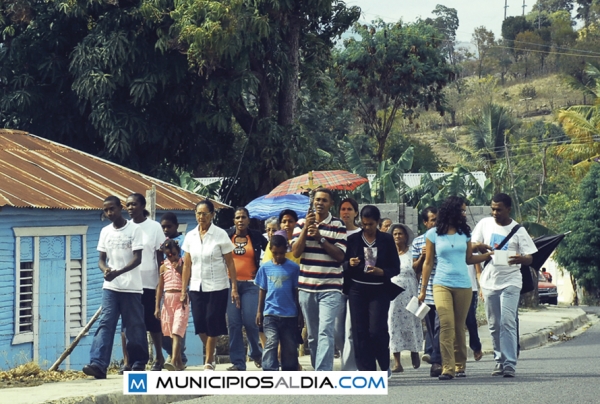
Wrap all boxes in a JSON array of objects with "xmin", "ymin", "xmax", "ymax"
[{"xmin": 83, "ymin": 196, "xmax": 148, "ymax": 379}]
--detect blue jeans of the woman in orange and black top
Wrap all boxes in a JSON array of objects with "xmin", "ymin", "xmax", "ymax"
[{"xmin": 227, "ymin": 281, "xmax": 262, "ymax": 370}]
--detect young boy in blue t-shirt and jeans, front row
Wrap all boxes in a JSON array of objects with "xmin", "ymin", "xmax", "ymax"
[{"xmin": 254, "ymin": 235, "xmax": 304, "ymax": 371}]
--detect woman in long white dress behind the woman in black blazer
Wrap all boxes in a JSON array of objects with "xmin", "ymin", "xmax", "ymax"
[{"xmin": 388, "ymin": 223, "xmax": 423, "ymax": 373}]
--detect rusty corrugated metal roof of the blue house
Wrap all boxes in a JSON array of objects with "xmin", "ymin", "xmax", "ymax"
[{"xmin": 0, "ymin": 129, "xmax": 228, "ymax": 210}]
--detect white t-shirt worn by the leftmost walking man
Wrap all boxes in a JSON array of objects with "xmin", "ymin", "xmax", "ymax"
[{"xmin": 97, "ymin": 221, "xmax": 144, "ymax": 293}]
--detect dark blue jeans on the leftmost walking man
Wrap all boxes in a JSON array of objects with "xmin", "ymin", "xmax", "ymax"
[{"xmin": 90, "ymin": 289, "xmax": 148, "ymax": 372}]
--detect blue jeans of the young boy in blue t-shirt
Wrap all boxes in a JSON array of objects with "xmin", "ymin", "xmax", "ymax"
[{"xmin": 262, "ymin": 316, "xmax": 298, "ymax": 371}]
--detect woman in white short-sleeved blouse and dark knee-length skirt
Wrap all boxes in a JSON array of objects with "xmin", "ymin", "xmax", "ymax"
[{"xmin": 181, "ymin": 199, "xmax": 240, "ymax": 370}]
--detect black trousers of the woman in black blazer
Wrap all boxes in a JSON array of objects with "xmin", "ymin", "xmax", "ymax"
[{"xmin": 348, "ymin": 281, "xmax": 390, "ymax": 371}]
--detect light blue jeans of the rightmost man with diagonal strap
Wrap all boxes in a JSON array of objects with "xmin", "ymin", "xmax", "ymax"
[{"xmin": 482, "ymin": 286, "xmax": 521, "ymax": 369}]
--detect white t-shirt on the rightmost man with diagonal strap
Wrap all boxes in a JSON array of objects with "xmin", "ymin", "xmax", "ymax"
[{"xmin": 471, "ymin": 217, "xmax": 537, "ymax": 290}]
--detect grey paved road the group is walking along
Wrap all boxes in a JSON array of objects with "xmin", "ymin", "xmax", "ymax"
[{"xmin": 178, "ymin": 322, "xmax": 600, "ymax": 404}]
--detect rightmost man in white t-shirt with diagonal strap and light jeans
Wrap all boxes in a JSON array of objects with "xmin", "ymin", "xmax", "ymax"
[{"xmin": 471, "ymin": 193, "xmax": 537, "ymax": 377}]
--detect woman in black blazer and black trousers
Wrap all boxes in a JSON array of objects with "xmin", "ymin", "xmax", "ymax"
[{"xmin": 344, "ymin": 205, "xmax": 400, "ymax": 374}]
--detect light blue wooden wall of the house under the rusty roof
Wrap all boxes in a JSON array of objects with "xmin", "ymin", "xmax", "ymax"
[{"xmin": 0, "ymin": 207, "xmax": 203, "ymax": 369}]
